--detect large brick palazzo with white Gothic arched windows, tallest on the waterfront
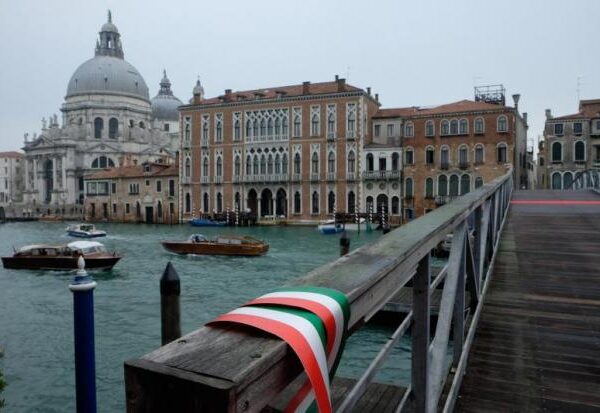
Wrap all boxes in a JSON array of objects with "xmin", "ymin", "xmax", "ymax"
[{"xmin": 180, "ymin": 76, "xmax": 379, "ymax": 223}]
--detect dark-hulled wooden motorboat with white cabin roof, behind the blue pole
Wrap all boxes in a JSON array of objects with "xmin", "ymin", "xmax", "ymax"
[{"xmin": 2, "ymin": 241, "xmax": 121, "ymax": 270}]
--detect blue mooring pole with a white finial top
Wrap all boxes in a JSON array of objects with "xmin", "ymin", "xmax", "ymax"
[{"xmin": 69, "ymin": 256, "xmax": 96, "ymax": 413}]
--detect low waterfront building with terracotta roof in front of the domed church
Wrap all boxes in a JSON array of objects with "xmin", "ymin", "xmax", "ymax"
[{"xmin": 84, "ymin": 162, "xmax": 179, "ymax": 224}]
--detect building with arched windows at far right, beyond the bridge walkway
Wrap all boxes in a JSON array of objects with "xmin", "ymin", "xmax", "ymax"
[{"xmin": 538, "ymin": 99, "xmax": 600, "ymax": 189}]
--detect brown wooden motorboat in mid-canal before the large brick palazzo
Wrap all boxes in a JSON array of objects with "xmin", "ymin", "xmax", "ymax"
[{"xmin": 161, "ymin": 234, "xmax": 269, "ymax": 256}]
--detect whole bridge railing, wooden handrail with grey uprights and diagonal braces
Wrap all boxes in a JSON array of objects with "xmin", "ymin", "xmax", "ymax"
[{"xmin": 125, "ymin": 170, "xmax": 513, "ymax": 412}]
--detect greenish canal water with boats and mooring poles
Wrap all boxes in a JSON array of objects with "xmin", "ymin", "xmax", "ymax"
[{"xmin": 0, "ymin": 222, "xmax": 410, "ymax": 412}]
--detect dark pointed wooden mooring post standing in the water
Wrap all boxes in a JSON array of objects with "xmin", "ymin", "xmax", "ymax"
[{"xmin": 160, "ymin": 261, "xmax": 181, "ymax": 346}]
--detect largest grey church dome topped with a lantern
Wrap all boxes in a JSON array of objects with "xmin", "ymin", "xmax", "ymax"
[{"xmin": 66, "ymin": 13, "xmax": 150, "ymax": 101}]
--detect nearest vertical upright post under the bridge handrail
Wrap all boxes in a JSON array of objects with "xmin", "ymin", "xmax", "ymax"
[{"xmin": 411, "ymin": 254, "xmax": 430, "ymax": 412}]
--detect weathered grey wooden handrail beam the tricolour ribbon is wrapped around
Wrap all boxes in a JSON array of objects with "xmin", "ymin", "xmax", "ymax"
[{"xmin": 125, "ymin": 171, "xmax": 508, "ymax": 412}]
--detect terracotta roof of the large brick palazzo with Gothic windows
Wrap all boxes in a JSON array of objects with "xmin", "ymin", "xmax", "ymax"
[{"xmin": 195, "ymin": 79, "xmax": 362, "ymax": 105}]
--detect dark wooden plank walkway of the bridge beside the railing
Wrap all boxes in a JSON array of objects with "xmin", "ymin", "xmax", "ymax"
[{"xmin": 456, "ymin": 191, "xmax": 600, "ymax": 412}]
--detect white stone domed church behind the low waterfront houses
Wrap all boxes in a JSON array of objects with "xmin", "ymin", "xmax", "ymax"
[{"xmin": 23, "ymin": 11, "xmax": 182, "ymax": 210}]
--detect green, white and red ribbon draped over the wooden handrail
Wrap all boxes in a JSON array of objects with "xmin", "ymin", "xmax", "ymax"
[{"xmin": 207, "ymin": 287, "xmax": 350, "ymax": 413}]
